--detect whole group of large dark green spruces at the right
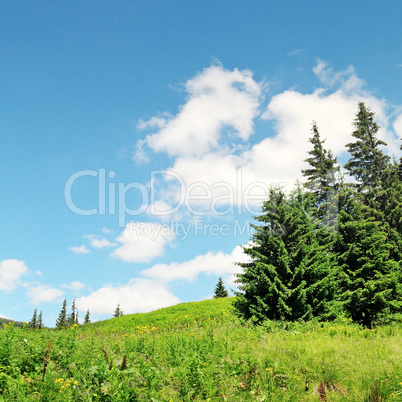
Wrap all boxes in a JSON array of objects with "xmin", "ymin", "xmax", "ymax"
[{"xmin": 234, "ymin": 102, "xmax": 402, "ymax": 327}]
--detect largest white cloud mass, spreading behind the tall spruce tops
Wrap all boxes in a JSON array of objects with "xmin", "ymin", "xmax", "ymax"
[{"xmin": 139, "ymin": 60, "xmax": 402, "ymax": 216}]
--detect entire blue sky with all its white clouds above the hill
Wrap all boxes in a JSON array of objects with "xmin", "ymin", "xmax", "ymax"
[{"xmin": 0, "ymin": 0, "xmax": 402, "ymax": 326}]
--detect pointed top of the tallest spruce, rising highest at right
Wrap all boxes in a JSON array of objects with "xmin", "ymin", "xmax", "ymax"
[{"xmin": 345, "ymin": 102, "xmax": 390, "ymax": 192}]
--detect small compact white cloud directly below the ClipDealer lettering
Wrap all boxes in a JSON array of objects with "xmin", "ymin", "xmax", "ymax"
[{"xmin": 111, "ymin": 221, "xmax": 175, "ymax": 262}]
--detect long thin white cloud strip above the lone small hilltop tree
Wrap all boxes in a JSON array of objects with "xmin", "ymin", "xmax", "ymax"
[{"xmin": 141, "ymin": 246, "xmax": 249, "ymax": 282}]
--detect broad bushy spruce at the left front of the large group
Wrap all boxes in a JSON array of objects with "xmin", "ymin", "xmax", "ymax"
[{"xmin": 234, "ymin": 187, "xmax": 335, "ymax": 323}]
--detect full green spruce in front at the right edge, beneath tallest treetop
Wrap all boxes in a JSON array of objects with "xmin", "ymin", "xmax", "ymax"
[{"xmin": 334, "ymin": 189, "xmax": 402, "ymax": 327}]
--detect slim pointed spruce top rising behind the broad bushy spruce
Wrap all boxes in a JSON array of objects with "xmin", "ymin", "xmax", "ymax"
[{"xmin": 302, "ymin": 122, "xmax": 340, "ymax": 223}]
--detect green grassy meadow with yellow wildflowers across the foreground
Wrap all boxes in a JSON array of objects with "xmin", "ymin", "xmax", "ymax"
[{"xmin": 0, "ymin": 298, "xmax": 402, "ymax": 401}]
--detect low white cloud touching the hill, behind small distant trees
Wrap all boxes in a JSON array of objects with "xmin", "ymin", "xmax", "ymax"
[{"xmin": 75, "ymin": 278, "xmax": 180, "ymax": 314}]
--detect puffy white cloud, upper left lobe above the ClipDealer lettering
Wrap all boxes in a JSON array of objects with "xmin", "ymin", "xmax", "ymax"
[{"xmin": 134, "ymin": 65, "xmax": 262, "ymax": 160}]
